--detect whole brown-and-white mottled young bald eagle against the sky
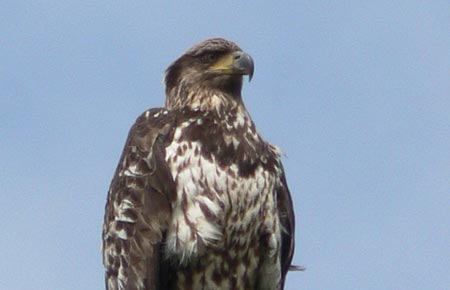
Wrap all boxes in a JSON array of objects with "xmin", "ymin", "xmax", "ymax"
[{"xmin": 102, "ymin": 38, "xmax": 294, "ymax": 290}]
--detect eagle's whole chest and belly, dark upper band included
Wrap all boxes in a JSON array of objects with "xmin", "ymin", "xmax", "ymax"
[{"xmin": 165, "ymin": 111, "xmax": 280, "ymax": 289}]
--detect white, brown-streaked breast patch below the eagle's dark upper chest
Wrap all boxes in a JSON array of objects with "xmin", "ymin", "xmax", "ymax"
[{"xmin": 166, "ymin": 120, "xmax": 280, "ymax": 268}]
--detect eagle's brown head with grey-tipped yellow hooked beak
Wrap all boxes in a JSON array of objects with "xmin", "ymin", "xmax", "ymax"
[{"xmin": 164, "ymin": 38, "xmax": 254, "ymax": 107}]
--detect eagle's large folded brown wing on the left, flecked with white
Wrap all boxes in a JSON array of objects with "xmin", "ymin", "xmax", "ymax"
[{"xmin": 103, "ymin": 109, "xmax": 175, "ymax": 290}]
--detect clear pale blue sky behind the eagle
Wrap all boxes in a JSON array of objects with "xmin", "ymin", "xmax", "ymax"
[{"xmin": 0, "ymin": 0, "xmax": 450, "ymax": 290}]
